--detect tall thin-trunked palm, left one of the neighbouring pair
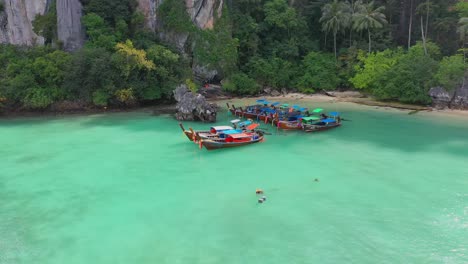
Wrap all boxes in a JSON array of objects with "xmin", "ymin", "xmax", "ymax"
[{"xmin": 320, "ymin": 0, "xmax": 351, "ymax": 58}]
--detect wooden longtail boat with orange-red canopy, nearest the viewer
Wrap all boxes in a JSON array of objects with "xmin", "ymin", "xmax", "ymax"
[{"xmin": 200, "ymin": 132, "xmax": 263, "ymax": 150}]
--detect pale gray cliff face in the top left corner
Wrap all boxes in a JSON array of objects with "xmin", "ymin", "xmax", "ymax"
[{"xmin": 0, "ymin": 0, "xmax": 49, "ymax": 46}]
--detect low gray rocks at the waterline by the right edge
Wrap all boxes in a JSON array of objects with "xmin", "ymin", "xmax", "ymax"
[{"xmin": 429, "ymin": 78, "xmax": 468, "ymax": 110}]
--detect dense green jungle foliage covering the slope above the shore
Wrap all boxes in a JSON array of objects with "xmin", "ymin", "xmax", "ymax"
[{"xmin": 0, "ymin": 0, "xmax": 468, "ymax": 109}]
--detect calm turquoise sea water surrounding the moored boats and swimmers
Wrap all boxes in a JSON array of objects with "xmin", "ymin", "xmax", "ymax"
[{"xmin": 0, "ymin": 104, "xmax": 468, "ymax": 264}]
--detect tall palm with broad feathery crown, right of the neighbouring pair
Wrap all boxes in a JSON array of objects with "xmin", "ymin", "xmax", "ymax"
[{"xmin": 353, "ymin": 1, "xmax": 387, "ymax": 53}]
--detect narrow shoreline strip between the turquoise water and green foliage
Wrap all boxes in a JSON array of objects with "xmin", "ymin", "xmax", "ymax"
[{"xmin": 0, "ymin": 91, "xmax": 468, "ymax": 120}]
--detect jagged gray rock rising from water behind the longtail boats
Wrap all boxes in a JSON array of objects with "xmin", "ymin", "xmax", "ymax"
[{"xmin": 174, "ymin": 84, "xmax": 218, "ymax": 122}]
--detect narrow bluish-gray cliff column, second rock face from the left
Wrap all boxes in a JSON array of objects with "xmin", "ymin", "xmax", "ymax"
[{"xmin": 57, "ymin": 0, "xmax": 84, "ymax": 51}]
